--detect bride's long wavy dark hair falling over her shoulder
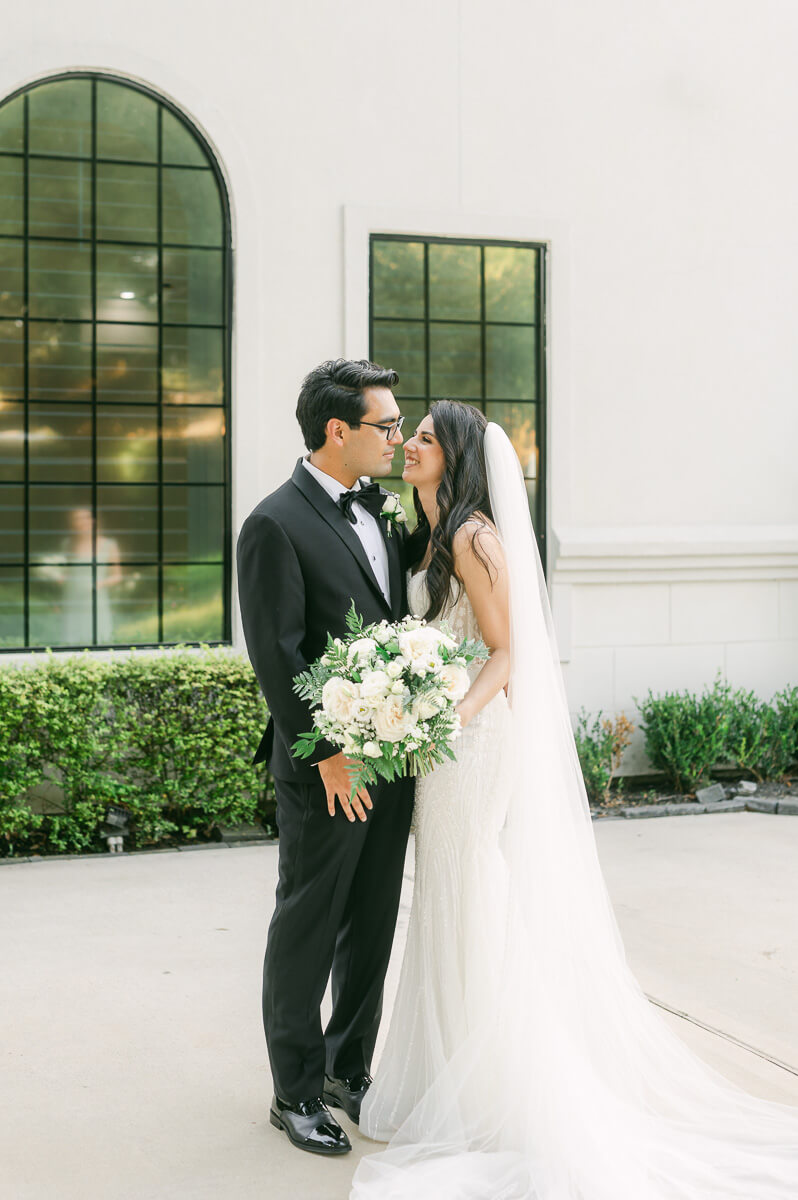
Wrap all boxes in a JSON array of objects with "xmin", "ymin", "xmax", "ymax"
[{"xmin": 407, "ymin": 400, "xmax": 493, "ymax": 620}]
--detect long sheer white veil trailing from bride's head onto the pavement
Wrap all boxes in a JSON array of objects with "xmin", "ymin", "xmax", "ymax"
[{"xmin": 352, "ymin": 424, "xmax": 798, "ymax": 1200}]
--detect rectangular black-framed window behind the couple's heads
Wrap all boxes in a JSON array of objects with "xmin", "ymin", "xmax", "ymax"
[{"xmin": 368, "ymin": 234, "xmax": 546, "ymax": 565}]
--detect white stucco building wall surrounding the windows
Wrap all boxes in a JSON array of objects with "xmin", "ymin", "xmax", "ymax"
[{"xmin": 0, "ymin": 0, "xmax": 798, "ymax": 768}]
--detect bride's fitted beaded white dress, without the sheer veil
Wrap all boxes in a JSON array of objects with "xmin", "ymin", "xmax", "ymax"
[{"xmin": 360, "ymin": 571, "xmax": 511, "ymax": 1141}]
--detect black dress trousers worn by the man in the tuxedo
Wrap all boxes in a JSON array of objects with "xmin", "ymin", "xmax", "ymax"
[{"xmin": 263, "ymin": 776, "xmax": 414, "ymax": 1102}]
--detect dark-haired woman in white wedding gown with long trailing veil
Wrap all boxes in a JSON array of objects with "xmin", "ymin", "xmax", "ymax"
[{"xmin": 352, "ymin": 401, "xmax": 798, "ymax": 1200}]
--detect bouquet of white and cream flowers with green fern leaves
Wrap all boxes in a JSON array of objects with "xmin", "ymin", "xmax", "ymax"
[{"xmin": 292, "ymin": 601, "xmax": 488, "ymax": 796}]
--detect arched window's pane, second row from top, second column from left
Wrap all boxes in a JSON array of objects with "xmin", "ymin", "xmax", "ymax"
[{"xmin": 28, "ymin": 158, "xmax": 91, "ymax": 238}]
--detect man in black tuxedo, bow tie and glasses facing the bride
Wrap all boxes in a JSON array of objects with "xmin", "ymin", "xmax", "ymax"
[{"xmin": 238, "ymin": 359, "xmax": 413, "ymax": 1154}]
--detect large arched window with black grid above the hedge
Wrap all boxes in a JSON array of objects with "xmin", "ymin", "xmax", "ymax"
[{"xmin": 0, "ymin": 73, "xmax": 230, "ymax": 650}]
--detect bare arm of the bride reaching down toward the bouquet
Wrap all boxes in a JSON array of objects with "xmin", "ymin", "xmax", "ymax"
[{"xmin": 452, "ymin": 521, "xmax": 510, "ymax": 726}]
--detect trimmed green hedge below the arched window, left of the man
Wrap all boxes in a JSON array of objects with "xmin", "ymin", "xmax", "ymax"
[{"xmin": 0, "ymin": 647, "xmax": 274, "ymax": 856}]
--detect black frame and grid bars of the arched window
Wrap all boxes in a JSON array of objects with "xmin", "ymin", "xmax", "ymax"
[{"xmin": 0, "ymin": 71, "xmax": 234, "ymax": 656}]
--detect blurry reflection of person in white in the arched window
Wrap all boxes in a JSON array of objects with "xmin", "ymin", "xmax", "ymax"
[{"xmin": 61, "ymin": 509, "xmax": 122, "ymax": 646}]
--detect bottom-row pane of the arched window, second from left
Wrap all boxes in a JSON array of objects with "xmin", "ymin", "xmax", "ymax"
[{"xmin": 30, "ymin": 565, "xmax": 92, "ymax": 646}]
